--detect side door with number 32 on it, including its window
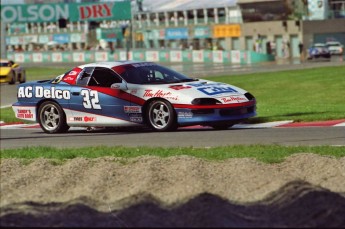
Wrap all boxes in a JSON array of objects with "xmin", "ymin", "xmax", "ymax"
[{"xmin": 70, "ymin": 67, "xmax": 130, "ymax": 126}]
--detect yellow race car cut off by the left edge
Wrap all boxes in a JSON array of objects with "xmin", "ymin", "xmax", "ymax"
[{"xmin": 0, "ymin": 59, "xmax": 26, "ymax": 84}]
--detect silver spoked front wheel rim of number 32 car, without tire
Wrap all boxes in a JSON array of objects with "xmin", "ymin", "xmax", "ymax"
[{"xmin": 150, "ymin": 102, "xmax": 171, "ymax": 129}]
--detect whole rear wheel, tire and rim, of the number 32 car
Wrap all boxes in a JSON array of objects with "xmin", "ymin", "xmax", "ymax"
[{"xmin": 38, "ymin": 101, "xmax": 69, "ymax": 134}]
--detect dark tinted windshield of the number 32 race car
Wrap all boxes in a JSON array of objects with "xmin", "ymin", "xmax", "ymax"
[{"xmin": 114, "ymin": 63, "xmax": 197, "ymax": 84}]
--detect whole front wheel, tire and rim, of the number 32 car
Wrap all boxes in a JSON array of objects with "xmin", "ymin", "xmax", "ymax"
[{"xmin": 146, "ymin": 100, "xmax": 177, "ymax": 132}]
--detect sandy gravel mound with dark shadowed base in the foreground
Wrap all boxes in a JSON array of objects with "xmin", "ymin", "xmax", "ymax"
[{"xmin": 0, "ymin": 154, "xmax": 345, "ymax": 227}]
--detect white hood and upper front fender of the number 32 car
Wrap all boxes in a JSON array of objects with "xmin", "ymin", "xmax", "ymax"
[{"xmin": 128, "ymin": 80, "xmax": 248, "ymax": 104}]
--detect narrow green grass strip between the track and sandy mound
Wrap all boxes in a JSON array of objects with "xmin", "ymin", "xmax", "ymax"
[{"xmin": 1, "ymin": 145, "xmax": 345, "ymax": 163}]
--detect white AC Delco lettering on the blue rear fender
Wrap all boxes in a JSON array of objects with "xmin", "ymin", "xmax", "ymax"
[{"xmin": 18, "ymin": 86, "xmax": 71, "ymax": 100}]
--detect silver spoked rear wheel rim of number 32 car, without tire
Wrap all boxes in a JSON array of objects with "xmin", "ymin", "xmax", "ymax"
[{"xmin": 41, "ymin": 104, "xmax": 60, "ymax": 130}]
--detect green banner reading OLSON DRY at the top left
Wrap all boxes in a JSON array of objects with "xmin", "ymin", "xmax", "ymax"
[{"xmin": 0, "ymin": 1, "xmax": 131, "ymax": 23}]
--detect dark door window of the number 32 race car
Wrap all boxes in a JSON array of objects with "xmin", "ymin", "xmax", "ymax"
[{"xmin": 88, "ymin": 67, "xmax": 122, "ymax": 87}]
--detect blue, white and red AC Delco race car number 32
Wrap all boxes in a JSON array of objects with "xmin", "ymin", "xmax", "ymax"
[{"xmin": 12, "ymin": 61, "xmax": 256, "ymax": 133}]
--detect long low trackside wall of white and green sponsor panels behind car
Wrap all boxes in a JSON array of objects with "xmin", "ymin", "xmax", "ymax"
[{"xmin": 7, "ymin": 50, "xmax": 274, "ymax": 64}]
